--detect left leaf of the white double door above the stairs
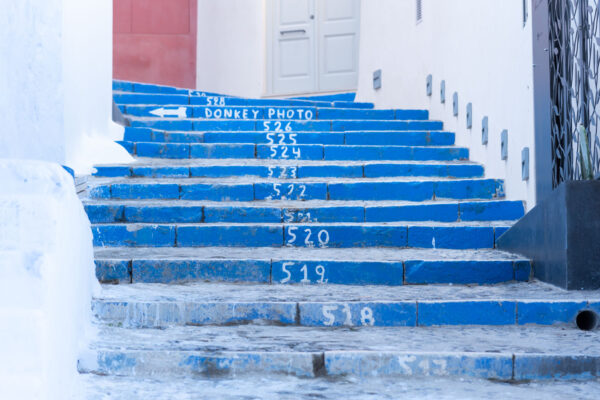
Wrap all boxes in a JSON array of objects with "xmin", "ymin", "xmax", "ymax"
[{"xmin": 272, "ymin": 0, "xmax": 317, "ymax": 93}]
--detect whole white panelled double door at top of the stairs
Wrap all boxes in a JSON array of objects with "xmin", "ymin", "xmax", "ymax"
[{"xmin": 269, "ymin": 0, "xmax": 360, "ymax": 94}]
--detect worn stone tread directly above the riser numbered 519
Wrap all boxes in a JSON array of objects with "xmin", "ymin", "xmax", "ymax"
[{"xmin": 94, "ymin": 247, "xmax": 526, "ymax": 262}]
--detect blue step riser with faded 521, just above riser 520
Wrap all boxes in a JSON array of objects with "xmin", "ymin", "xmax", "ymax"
[{"xmin": 85, "ymin": 201, "xmax": 524, "ymax": 223}]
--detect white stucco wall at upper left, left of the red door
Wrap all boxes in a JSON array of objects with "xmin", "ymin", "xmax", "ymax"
[{"xmin": 0, "ymin": 0, "xmax": 130, "ymax": 173}]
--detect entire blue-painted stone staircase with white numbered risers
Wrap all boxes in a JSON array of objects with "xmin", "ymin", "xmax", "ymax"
[{"xmin": 80, "ymin": 82, "xmax": 600, "ymax": 398}]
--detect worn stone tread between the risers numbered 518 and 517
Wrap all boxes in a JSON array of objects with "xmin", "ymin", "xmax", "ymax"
[{"xmin": 92, "ymin": 323, "xmax": 600, "ymax": 356}]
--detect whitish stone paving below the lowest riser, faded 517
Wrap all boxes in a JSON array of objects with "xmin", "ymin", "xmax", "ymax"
[{"xmin": 81, "ymin": 374, "xmax": 600, "ymax": 400}]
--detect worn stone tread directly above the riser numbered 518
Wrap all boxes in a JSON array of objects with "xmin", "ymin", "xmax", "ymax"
[{"xmin": 96, "ymin": 281, "xmax": 600, "ymax": 302}]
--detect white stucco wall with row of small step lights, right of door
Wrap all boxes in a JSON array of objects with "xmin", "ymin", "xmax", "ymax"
[{"xmin": 357, "ymin": 0, "xmax": 535, "ymax": 209}]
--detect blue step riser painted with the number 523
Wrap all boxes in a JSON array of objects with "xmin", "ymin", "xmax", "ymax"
[{"xmin": 94, "ymin": 164, "xmax": 483, "ymax": 179}]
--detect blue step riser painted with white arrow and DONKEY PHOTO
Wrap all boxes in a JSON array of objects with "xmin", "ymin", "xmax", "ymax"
[{"xmin": 120, "ymin": 106, "xmax": 429, "ymax": 120}]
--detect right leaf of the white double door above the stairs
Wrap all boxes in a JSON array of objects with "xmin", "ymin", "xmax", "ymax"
[{"xmin": 317, "ymin": 0, "xmax": 360, "ymax": 91}]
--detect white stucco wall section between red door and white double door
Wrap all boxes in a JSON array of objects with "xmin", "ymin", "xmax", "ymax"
[{"xmin": 196, "ymin": 0, "xmax": 266, "ymax": 97}]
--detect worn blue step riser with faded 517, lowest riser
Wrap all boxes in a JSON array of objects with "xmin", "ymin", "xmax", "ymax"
[{"xmin": 79, "ymin": 350, "xmax": 600, "ymax": 381}]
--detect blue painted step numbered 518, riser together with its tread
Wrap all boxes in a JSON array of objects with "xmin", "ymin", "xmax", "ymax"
[{"xmin": 93, "ymin": 283, "xmax": 600, "ymax": 328}]
